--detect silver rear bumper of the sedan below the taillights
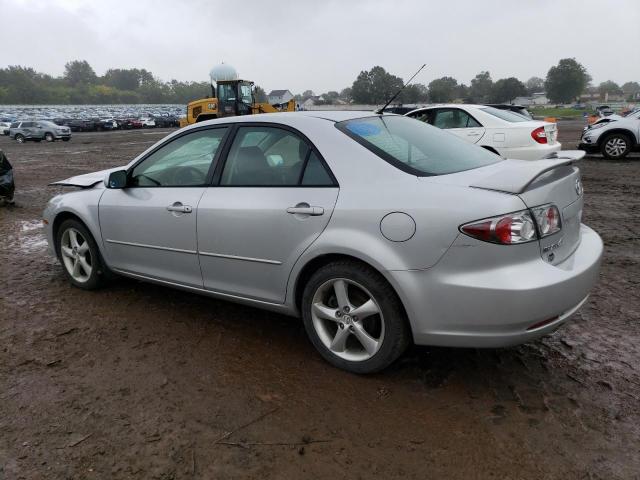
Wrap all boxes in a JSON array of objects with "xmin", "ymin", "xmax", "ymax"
[{"xmin": 389, "ymin": 225, "xmax": 603, "ymax": 348}]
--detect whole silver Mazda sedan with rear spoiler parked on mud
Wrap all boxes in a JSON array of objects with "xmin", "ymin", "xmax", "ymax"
[{"xmin": 44, "ymin": 112, "xmax": 602, "ymax": 373}]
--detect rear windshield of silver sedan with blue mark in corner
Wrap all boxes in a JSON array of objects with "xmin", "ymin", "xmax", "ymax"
[{"xmin": 336, "ymin": 116, "xmax": 502, "ymax": 177}]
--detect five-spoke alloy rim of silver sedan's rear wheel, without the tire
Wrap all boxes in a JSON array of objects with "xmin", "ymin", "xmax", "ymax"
[{"xmin": 311, "ymin": 278, "xmax": 385, "ymax": 361}]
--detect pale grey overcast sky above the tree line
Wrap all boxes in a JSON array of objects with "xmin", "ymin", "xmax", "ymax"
[{"xmin": 0, "ymin": 0, "xmax": 640, "ymax": 93}]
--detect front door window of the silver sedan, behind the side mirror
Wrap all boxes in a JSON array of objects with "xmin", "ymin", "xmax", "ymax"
[{"xmin": 129, "ymin": 127, "xmax": 227, "ymax": 187}]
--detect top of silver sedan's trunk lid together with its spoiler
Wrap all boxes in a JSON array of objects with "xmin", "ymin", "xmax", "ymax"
[{"xmin": 420, "ymin": 150, "xmax": 585, "ymax": 194}]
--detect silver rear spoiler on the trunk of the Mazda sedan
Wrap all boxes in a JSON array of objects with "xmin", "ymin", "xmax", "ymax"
[{"xmin": 470, "ymin": 150, "xmax": 586, "ymax": 194}]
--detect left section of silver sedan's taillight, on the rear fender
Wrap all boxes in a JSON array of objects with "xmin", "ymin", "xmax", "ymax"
[{"xmin": 460, "ymin": 210, "xmax": 536, "ymax": 245}]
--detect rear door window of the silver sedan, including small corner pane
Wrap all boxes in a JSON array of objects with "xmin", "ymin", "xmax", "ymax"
[{"xmin": 220, "ymin": 126, "xmax": 333, "ymax": 187}]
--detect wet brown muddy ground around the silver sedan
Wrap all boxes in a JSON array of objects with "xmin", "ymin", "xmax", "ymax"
[{"xmin": 0, "ymin": 122, "xmax": 640, "ymax": 480}]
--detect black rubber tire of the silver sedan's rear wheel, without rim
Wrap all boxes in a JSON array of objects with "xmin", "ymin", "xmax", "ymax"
[{"xmin": 301, "ymin": 260, "xmax": 411, "ymax": 374}]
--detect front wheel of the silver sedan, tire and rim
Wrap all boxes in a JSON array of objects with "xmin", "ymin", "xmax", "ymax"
[{"xmin": 56, "ymin": 219, "xmax": 105, "ymax": 290}]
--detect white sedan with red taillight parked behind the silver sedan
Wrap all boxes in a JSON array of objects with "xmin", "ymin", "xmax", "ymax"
[{"xmin": 406, "ymin": 104, "xmax": 562, "ymax": 160}]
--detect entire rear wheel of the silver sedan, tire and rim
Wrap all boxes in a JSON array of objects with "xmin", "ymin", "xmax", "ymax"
[{"xmin": 302, "ymin": 261, "xmax": 411, "ymax": 373}]
